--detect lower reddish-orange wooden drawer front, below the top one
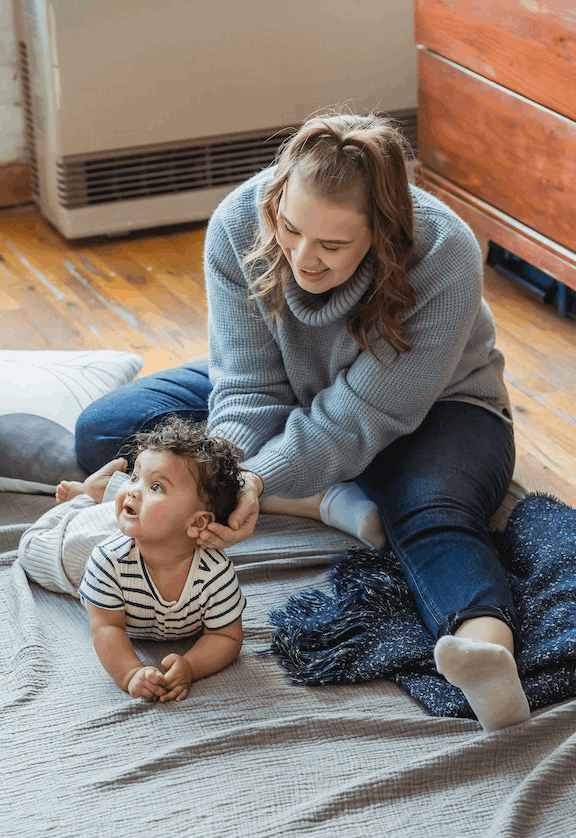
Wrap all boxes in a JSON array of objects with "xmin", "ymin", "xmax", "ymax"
[{"xmin": 418, "ymin": 49, "xmax": 576, "ymax": 250}]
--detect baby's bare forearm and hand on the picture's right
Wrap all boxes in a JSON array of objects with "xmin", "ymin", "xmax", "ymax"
[{"xmin": 160, "ymin": 617, "xmax": 244, "ymax": 701}]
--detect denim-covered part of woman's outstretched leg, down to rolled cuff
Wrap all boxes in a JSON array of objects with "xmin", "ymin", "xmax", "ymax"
[{"xmin": 359, "ymin": 402, "xmax": 515, "ymax": 637}]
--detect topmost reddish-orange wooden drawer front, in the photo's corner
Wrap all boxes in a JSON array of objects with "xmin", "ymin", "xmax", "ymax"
[{"xmin": 415, "ymin": 0, "xmax": 576, "ymax": 119}]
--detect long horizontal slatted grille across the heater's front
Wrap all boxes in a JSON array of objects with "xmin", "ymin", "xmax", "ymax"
[{"xmin": 56, "ymin": 109, "xmax": 417, "ymax": 209}]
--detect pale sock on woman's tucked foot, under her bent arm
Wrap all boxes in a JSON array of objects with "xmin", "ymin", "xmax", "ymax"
[{"xmin": 320, "ymin": 483, "xmax": 386, "ymax": 549}]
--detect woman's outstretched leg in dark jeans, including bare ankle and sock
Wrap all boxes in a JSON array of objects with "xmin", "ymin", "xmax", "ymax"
[{"xmin": 360, "ymin": 402, "xmax": 529, "ymax": 730}]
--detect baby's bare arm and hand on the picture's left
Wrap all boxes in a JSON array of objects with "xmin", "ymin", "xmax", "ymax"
[{"xmin": 85, "ymin": 602, "xmax": 166, "ymax": 700}]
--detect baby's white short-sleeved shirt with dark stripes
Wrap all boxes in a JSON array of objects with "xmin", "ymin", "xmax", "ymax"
[{"xmin": 79, "ymin": 531, "xmax": 246, "ymax": 640}]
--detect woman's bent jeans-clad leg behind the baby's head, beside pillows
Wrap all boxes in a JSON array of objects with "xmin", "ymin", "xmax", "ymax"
[{"xmin": 75, "ymin": 361, "xmax": 212, "ymax": 474}]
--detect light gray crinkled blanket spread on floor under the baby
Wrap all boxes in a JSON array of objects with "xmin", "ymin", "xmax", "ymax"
[{"xmin": 0, "ymin": 493, "xmax": 576, "ymax": 838}]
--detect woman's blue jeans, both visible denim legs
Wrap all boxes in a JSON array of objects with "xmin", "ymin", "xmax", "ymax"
[{"xmin": 76, "ymin": 362, "xmax": 517, "ymax": 637}]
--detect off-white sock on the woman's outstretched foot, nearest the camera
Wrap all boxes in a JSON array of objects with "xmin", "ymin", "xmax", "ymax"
[{"xmin": 434, "ymin": 635, "xmax": 530, "ymax": 731}]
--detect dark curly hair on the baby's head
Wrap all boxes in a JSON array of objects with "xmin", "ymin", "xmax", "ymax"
[{"xmin": 126, "ymin": 415, "xmax": 244, "ymax": 524}]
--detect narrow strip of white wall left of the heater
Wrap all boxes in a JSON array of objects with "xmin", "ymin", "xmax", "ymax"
[{"xmin": 0, "ymin": 0, "xmax": 25, "ymax": 163}]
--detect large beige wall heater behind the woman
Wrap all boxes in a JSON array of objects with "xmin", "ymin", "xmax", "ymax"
[{"xmin": 15, "ymin": 0, "xmax": 416, "ymax": 239}]
